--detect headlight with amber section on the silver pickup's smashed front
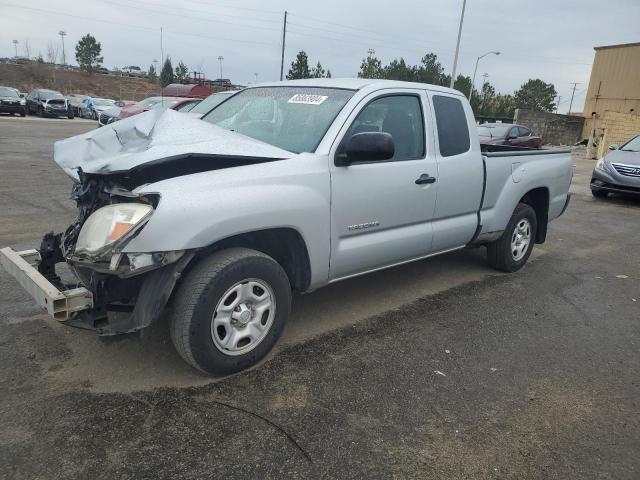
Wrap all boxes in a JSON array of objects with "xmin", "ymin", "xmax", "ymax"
[{"xmin": 75, "ymin": 203, "xmax": 153, "ymax": 255}]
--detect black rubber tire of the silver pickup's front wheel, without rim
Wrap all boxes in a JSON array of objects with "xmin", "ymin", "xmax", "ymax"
[{"xmin": 168, "ymin": 248, "xmax": 291, "ymax": 375}]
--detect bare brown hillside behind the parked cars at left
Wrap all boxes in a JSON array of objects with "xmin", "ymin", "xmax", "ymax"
[{"xmin": 0, "ymin": 63, "xmax": 159, "ymax": 100}]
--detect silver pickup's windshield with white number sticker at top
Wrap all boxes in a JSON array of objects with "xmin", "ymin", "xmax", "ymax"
[{"xmin": 202, "ymin": 87, "xmax": 354, "ymax": 153}]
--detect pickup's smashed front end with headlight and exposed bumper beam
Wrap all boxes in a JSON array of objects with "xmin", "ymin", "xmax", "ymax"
[{"xmin": 0, "ymin": 170, "xmax": 194, "ymax": 335}]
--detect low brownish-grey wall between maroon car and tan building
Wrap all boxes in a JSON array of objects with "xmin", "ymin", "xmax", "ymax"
[{"xmin": 513, "ymin": 108, "xmax": 584, "ymax": 145}]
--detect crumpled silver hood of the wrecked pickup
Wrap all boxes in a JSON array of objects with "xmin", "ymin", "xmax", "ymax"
[{"xmin": 54, "ymin": 109, "xmax": 295, "ymax": 180}]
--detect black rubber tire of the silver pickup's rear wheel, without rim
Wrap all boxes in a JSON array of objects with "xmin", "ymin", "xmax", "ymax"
[{"xmin": 487, "ymin": 203, "xmax": 538, "ymax": 272}]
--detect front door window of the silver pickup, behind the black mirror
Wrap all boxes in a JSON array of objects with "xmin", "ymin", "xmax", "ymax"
[{"xmin": 345, "ymin": 95, "xmax": 425, "ymax": 161}]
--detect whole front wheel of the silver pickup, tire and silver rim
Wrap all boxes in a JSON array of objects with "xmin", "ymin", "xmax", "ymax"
[{"xmin": 169, "ymin": 248, "xmax": 291, "ymax": 375}]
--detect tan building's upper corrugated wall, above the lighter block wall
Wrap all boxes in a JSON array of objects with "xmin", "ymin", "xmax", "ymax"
[{"xmin": 584, "ymin": 42, "xmax": 640, "ymax": 117}]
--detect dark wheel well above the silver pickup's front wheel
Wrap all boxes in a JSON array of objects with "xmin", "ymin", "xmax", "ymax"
[{"xmin": 200, "ymin": 228, "xmax": 311, "ymax": 292}]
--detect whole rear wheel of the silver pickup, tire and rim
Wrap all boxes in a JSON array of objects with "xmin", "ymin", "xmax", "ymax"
[{"xmin": 487, "ymin": 203, "xmax": 538, "ymax": 272}]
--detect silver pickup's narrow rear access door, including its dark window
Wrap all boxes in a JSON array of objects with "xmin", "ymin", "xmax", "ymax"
[{"xmin": 429, "ymin": 92, "xmax": 484, "ymax": 252}]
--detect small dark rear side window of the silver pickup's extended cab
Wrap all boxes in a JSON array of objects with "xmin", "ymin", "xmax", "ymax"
[{"xmin": 433, "ymin": 95, "xmax": 471, "ymax": 157}]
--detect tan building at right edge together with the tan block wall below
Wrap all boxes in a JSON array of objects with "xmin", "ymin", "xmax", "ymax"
[{"xmin": 582, "ymin": 42, "xmax": 640, "ymax": 158}]
